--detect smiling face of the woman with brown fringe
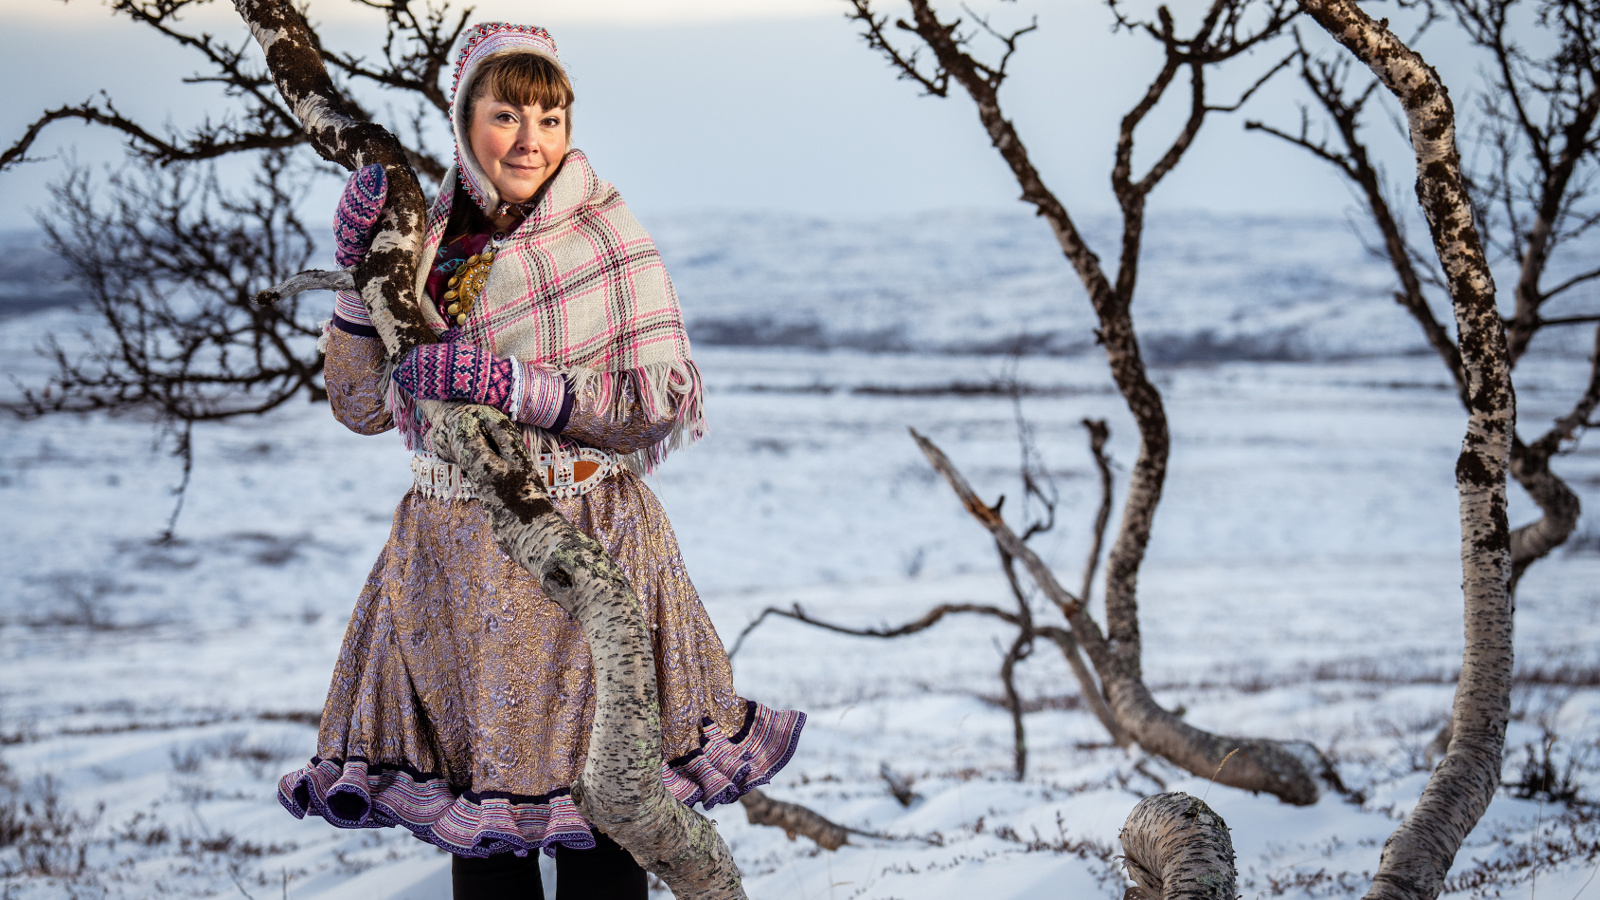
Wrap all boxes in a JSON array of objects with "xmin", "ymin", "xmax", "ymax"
[{"xmin": 469, "ymin": 96, "xmax": 566, "ymax": 203}]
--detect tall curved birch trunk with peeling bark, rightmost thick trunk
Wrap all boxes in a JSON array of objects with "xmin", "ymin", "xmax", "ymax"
[{"xmin": 1301, "ymin": 7, "xmax": 1515, "ymax": 900}]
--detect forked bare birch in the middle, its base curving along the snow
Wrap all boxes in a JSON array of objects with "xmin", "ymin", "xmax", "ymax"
[{"xmin": 832, "ymin": 0, "xmax": 1322, "ymax": 804}]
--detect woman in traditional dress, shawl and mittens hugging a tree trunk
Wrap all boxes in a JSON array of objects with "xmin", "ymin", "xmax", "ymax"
[{"xmin": 278, "ymin": 24, "xmax": 805, "ymax": 898}]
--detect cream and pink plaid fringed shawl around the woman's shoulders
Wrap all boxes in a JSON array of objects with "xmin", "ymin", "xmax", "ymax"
[{"xmin": 403, "ymin": 149, "xmax": 706, "ymax": 471}]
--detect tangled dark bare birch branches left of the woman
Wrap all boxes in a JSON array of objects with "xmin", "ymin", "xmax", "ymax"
[{"xmin": 0, "ymin": 0, "xmax": 470, "ymax": 540}]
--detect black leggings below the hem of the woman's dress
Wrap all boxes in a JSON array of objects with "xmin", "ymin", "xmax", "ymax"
[{"xmin": 450, "ymin": 831, "xmax": 650, "ymax": 900}]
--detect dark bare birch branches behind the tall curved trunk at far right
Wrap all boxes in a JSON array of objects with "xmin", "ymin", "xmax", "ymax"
[{"xmin": 1245, "ymin": 0, "xmax": 1600, "ymax": 589}]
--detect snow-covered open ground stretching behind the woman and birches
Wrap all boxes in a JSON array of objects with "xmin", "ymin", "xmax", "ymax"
[{"xmin": 0, "ymin": 216, "xmax": 1600, "ymax": 900}]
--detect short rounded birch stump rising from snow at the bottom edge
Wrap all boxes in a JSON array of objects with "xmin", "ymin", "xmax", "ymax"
[{"xmin": 1117, "ymin": 793, "xmax": 1238, "ymax": 900}]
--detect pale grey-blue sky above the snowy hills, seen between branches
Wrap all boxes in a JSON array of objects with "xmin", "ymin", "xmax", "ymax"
[{"xmin": 0, "ymin": 0, "xmax": 1470, "ymax": 227}]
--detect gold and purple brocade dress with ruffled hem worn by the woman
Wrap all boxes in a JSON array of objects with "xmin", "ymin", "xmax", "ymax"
[{"xmin": 278, "ymin": 328, "xmax": 805, "ymax": 857}]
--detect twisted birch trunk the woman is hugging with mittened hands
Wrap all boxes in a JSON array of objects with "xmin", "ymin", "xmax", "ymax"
[{"xmin": 234, "ymin": 0, "xmax": 744, "ymax": 900}]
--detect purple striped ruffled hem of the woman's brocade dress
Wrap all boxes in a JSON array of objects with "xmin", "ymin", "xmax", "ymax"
[{"xmin": 278, "ymin": 700, "xmax": 805, "ymax": 857}]
